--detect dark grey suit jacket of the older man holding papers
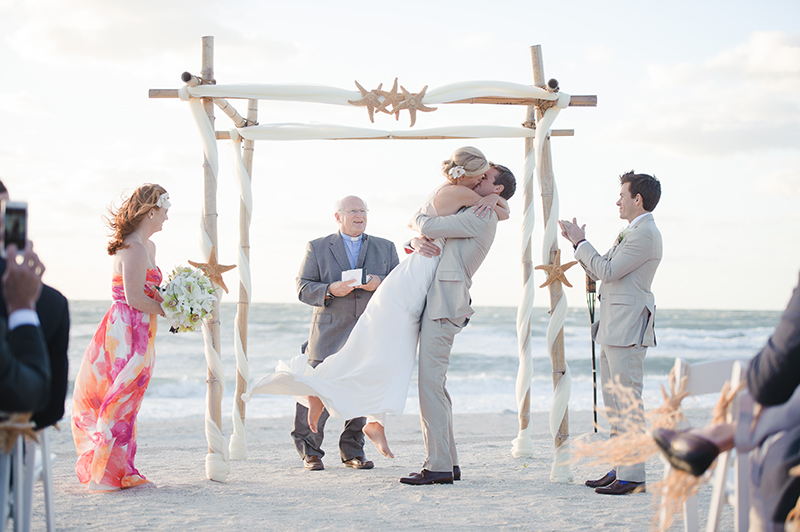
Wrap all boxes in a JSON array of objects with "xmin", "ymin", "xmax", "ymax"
[{"xmin": 296, "ymin": 232, "xmax": 400, "ymax": 360}]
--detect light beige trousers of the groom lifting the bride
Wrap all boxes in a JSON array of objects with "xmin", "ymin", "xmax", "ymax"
[{"xmin": 419, "ymin": 307, "xmax": 466, "ymax": 472}]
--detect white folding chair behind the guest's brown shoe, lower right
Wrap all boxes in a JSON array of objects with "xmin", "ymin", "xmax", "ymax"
[{"xmin": 660, "ymin": 358, "xmax": 752, "ymax": 532}]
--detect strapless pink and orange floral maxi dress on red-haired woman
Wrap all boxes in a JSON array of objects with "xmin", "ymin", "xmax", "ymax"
[{"xmin": 72, "ymin": 268, "xmax": 162, "ymax": 488}]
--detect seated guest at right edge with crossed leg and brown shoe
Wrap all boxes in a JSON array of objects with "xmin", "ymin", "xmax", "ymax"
[{"xmin": 653, "ymin": 272, "xmax": 800, "ymax": 531}]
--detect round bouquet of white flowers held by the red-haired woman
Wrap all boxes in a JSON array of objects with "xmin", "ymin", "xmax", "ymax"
[{"xmin": 159, "ymin": 266, "xmax": 217, "ymax": 333}]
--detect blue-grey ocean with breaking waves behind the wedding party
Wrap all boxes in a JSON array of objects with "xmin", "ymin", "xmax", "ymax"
[{"xmin": 66, "ymin": 301, "xmax": 781, "ymax": 427}]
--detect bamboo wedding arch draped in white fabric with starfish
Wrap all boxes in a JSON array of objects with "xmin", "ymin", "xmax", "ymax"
[{"xmin": 149, "ymin": 37, "xmax": 597, "ymax": 482}]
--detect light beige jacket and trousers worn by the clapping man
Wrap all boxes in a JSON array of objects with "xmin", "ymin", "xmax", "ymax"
[{"xmin": 575, "ymin": 213, "xmax": 662, "ymax": 482}]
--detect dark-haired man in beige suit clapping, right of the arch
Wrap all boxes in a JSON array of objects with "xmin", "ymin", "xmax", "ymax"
[{"xmin": 559, "ymin": 171, "xmax": 662, "ymax": 495}]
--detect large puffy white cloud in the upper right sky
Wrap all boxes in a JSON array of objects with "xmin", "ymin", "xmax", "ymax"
[{"xmin": 618, "ymin": 31, "xmax": 800, "ymax": 156}]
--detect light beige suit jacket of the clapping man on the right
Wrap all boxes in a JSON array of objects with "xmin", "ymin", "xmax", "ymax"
[{"xmin": 575, "ymin": 213, "xmax": 662, "ymax": 347}]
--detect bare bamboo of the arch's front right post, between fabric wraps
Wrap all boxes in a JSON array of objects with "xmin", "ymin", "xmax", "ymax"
[{"xmin": 531, "ymin": 45, "xmax": 569, "ymax": 458}]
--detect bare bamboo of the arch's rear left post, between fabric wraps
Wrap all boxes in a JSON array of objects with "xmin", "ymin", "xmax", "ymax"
[{"xmin": 231, "ymin": 100, "xmax": 258, "ymax": 460}]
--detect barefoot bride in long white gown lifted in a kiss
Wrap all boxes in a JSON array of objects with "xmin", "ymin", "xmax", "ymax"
[{"xmin": 242, "ymin": 147, "xmax": 513, "ymax": 458}]
